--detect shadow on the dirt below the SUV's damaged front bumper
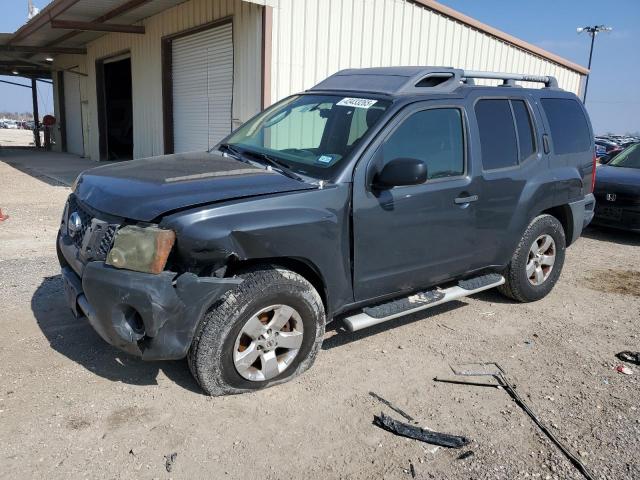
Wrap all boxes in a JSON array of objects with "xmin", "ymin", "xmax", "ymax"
[{"xmin": 31, "ymin": 275, "xmax": 203, "ymax": 394}]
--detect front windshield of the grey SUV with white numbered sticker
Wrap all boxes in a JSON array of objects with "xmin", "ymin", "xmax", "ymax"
[{"xmin": 223, "ymin": 95, "xmax": 391, "ymax": 179}]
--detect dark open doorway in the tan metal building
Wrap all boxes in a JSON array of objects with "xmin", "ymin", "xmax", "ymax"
[{"xmin": 96, "ymin": 54, "xmax": 133, "ymax": 160}]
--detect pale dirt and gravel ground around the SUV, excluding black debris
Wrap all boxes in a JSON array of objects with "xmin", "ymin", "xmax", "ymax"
[{"xmin": 0, "ymin": 155, "xmax": 640, "ymax": 480}]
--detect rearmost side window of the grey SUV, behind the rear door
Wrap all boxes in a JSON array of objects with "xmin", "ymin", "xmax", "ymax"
[{"xmin": 541, "ymin": 98, "xmax": 593, "ymax": 155}]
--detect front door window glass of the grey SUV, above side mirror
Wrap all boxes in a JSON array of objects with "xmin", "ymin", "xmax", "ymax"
[{"xmin": 382, "ymin": 108, "xmax": 464, "ymax": 179}]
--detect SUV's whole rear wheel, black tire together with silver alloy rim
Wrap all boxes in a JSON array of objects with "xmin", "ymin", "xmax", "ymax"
[{"xmin": 498, "ymin": 215, "xmax": 566, "ymax": 303}]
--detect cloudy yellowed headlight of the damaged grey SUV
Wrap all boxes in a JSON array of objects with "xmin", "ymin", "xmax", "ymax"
[{"xmin": 106, "ymin": 225, "xmax": 176, "ymax": 273}]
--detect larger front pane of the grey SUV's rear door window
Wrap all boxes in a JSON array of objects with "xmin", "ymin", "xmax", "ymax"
[{"xmin": 475, "ymin": 99, "xmax": 518, "ymax": 170}]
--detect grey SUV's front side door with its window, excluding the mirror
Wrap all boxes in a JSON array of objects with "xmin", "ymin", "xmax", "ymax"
[{"xmin": 353, "ymin": 101, "xmax": 478, "ymax": 301}]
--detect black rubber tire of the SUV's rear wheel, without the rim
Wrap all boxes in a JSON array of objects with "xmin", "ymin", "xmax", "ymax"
[{"xmin": 511, "ymin": 215, "xmax": 566, "ymax": 301}]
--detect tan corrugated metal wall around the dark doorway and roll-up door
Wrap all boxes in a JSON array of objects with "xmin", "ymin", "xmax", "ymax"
[{"xmin": 56, "ymin": 0, "xmax": 262, "ymax": 160}]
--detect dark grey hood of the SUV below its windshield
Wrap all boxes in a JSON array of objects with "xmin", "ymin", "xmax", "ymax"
[{"xmin": 75, "ymin": 152, "xmax": 317, "ymax": 222}]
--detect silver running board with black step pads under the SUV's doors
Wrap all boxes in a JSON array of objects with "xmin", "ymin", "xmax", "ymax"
[{"xmin": 344, "ymin": 273, "xmax": 504, "ymax": 332}]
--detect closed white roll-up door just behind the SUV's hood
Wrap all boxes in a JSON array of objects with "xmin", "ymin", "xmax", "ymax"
[{"xmin": 172, "ymin": 23, "xmax": 233, "ymax": 153}]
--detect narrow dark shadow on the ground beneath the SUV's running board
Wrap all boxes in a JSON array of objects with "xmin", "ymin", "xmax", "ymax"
[{"xmin": 322, "ymin": 300, "xmax": 467, "ymax": 350}]
